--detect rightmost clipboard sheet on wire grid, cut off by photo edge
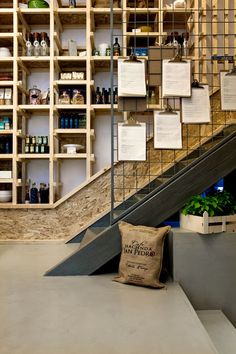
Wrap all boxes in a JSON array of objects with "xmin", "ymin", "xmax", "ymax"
[{"xmin": 220, "ymin": 71, "xmax": 236, "ymax": 111}]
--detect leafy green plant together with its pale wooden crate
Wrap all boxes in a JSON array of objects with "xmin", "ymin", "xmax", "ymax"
[{"xmin": 180, "ymin": 191, "xmax": 236, "ymax": 234}]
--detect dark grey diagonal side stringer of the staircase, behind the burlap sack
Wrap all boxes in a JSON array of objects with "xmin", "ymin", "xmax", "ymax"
[{"xmin": 46, "ymin": 132, "xmax": 236, "ymax": 276}]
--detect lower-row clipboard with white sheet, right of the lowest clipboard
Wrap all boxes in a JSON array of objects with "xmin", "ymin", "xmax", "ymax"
[{"xmin": 154, "ymin": 111, "xmax": 182, "ymax": 149}]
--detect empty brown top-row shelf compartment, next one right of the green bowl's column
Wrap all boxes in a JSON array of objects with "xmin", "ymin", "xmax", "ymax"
[{"xmin": 56, "ymin": 8, "xmax": 86, "ymax": 27}]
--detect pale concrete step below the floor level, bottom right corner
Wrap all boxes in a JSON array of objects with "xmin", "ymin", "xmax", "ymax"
[{"xmin": 197, "ymin": 310, "xmax": 236, "ymax": 354}]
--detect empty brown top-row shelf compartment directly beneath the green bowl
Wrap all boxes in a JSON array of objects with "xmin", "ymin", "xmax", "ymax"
[{"xmin": 18, "ymin": 8, "xmax": 50, "ymax": 25}]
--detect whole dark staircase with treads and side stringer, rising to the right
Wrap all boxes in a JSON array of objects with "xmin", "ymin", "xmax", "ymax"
[{"xmin": 46, "ymin": 125, "xmax": 236, "ymax": 276}]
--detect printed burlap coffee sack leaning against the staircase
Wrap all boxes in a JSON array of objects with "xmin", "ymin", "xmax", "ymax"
[{"xmin": 113, "ymin": 221, "xmax": 170, "ymax": 288}]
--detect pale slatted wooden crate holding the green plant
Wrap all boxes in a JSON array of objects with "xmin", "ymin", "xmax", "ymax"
[{"xmin": 180, "ymin": 211, "xmax": 236, "ymax": 234}]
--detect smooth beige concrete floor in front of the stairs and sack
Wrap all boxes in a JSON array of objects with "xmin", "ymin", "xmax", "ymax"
[{"xmin": 0, "ymin": 243, "xmax": 216, "ymax": 354}]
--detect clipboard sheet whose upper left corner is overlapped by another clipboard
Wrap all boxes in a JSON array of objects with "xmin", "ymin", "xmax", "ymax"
[{"xmin": 182, "ymin": 85, "xmax": 211, "ymax": 123}]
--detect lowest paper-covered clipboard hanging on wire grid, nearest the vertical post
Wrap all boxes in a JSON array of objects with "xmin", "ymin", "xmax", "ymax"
[{"xmin": 118, "ymin": 123, "xmax": 146, "ymax": 161}]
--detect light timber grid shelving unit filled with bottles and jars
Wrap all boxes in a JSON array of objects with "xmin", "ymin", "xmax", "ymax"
[{"xmin": 0, "ymin": 0, "xmax": 199, "ymax": 208}]
